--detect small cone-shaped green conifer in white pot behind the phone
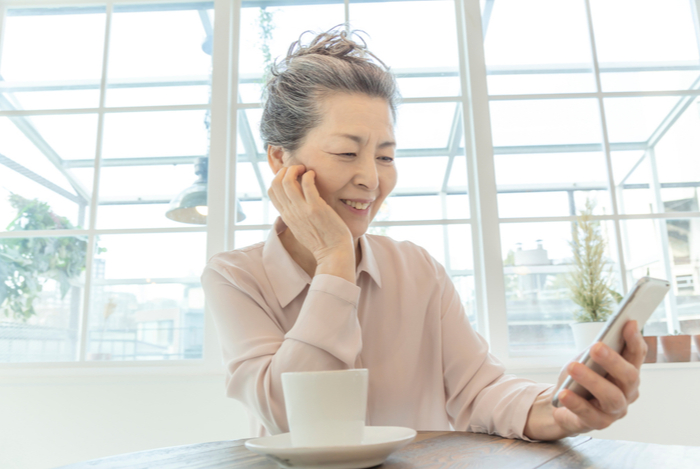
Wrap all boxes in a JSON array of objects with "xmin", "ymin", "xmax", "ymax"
[{"xmin": 566, "ymin": 200, "xmax": 622, "ymax": 322}]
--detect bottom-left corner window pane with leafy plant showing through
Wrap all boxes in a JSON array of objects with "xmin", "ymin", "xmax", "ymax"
[{"xmin": 0, "ymin": 237, "xmax": 87, "ymax": 362}]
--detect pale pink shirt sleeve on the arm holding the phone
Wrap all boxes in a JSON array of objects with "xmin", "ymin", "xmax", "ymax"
[{"xmin": 431, "ymin": 252, "xmax": 551, "ymax": 440}]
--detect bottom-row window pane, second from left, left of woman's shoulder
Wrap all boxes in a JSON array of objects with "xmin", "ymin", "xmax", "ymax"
[{"xmin": 87, "ymin": 233, "xmax": 206, "ymax": 360}]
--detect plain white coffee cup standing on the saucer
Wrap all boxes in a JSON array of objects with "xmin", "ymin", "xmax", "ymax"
[{"xmin": 282, "ymin": 368, "xmax": 369, "ymax": 447}]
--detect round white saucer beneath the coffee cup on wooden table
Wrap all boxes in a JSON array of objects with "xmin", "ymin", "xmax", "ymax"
[{"xmin": 245, "ymin": 427, "xmax": 416, "ymax": 469}]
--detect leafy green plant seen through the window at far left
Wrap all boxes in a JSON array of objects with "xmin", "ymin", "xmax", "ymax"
[{"xmin": 0, "ymin": 194, "xmax": 101, "ymax": 322}]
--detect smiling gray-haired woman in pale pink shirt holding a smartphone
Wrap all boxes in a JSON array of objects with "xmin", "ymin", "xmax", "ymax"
[{"xmin": 202, "ymin": 30, "xmax": 646, "ymax": 440}]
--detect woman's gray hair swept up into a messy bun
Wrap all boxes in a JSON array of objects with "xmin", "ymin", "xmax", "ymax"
[{"xmin": 260, "ymin": 25, "xmax": 400, "ymax": 152}]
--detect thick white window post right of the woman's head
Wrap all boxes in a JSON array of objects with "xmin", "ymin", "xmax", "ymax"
[{"xmin": 455, "ymin": 0, "xmax": 508, "ymax": 358}]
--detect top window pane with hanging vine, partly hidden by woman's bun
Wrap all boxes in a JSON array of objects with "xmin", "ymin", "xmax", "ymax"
[{"xmin": 238, "ymin": 0, "xmax": 345, "ymax": 102}]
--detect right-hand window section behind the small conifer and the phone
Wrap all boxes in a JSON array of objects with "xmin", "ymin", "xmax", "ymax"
[{"xmin": 481, "ymin": 0, "xmax": 700, "ymax": 356}]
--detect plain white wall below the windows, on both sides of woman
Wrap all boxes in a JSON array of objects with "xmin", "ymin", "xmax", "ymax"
[{"xmin": 0, "ymin": 362, "xmax": 700, "ymax": 469}]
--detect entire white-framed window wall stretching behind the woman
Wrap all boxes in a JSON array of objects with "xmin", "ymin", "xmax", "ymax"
[{"xmin": 0, "ymin": 0, "xmax": 700, "ymax": 366}]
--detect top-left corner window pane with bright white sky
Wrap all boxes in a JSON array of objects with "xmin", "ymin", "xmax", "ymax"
[{"xmin": 0, "ymin": 7, "xmax": 106, "ymax": 110}]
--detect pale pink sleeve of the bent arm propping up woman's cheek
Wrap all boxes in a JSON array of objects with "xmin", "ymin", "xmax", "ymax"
[{"xmin": 201, "ymin": 267, "xmax": 362, "ymax": 434}]
